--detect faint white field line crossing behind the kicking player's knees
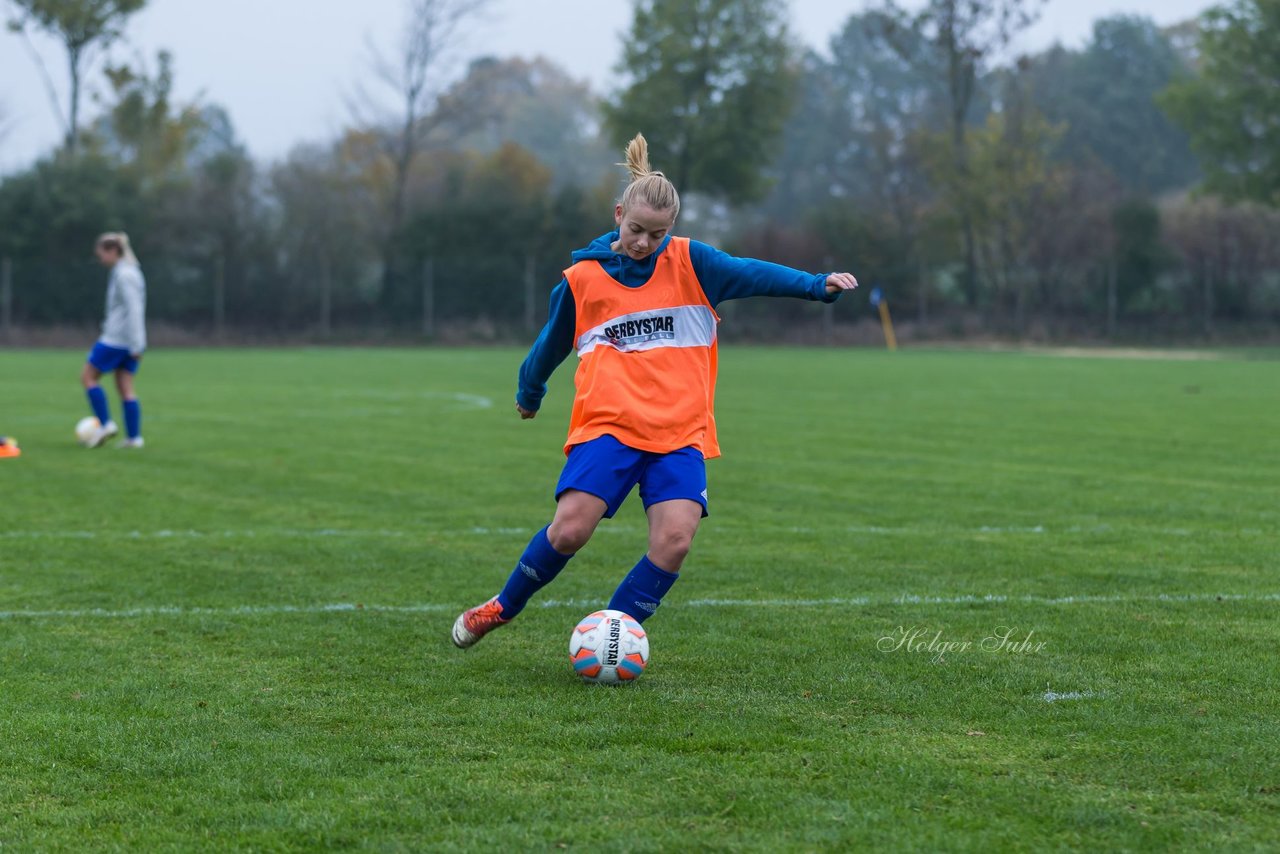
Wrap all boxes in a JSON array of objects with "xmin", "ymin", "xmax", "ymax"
[{"xmin": 0, "ymin": 524, "xmax": 1268, "ymax": 540}]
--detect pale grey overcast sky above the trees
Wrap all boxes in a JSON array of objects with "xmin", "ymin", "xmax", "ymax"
[{"xmin": 0, "ymin": 0, "xmax": 1212, "ymax": 173}]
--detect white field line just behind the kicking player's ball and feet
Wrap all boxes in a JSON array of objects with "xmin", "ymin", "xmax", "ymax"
[{"xmin": 0, "ymin": 593, "xmax": 1280, "ymax": 620}]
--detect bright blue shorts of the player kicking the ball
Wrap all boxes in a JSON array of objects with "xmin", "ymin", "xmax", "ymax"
[{"xmin": 556, "ymin": 435, "xmax": 707, "ymax": 519}]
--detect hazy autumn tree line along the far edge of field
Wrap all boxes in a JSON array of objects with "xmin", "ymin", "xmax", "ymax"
[{"xmin": 0, "ymin": 0, "xmax": 1280, "ymax": 338}]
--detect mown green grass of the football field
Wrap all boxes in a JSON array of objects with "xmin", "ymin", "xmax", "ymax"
[{"xmin": 0, "ymin": 347, "xmax": 1280, "ymax": 851}]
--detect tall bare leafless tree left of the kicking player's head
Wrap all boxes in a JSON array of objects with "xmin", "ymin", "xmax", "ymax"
[{"xmin": 352, "ymin": 0, "xmax": 492, "ymax": 306}]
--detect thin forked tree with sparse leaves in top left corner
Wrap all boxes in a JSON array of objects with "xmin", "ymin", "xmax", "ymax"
[{"xmin": 9, "ymin": 0, "xmax": 146, "ymax": 152}]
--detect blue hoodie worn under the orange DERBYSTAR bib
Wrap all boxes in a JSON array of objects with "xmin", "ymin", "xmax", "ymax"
[{"xmin": 516, "ymin": 232, "xmax": 840, "ymax": 411}]
